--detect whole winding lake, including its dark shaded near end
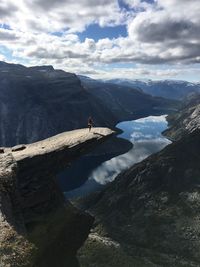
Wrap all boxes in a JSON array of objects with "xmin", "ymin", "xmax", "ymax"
[{"xmin": 59, "ymin": 115, "xmax": 171, "ymax": 199}]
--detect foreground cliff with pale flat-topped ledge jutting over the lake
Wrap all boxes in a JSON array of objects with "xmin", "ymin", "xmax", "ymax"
[{"xmin": 0, "ymin": 128, "xmax": 113, "ymax": 267}]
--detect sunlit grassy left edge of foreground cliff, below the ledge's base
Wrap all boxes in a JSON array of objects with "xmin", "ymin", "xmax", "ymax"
[{"xmin": 0, "ymin": 154, "xmax": 33, "ymax": 267}]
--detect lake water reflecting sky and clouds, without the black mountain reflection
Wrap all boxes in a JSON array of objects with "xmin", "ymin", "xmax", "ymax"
[{"xmin": 65, "ymin": 115, "xmax": 170, "ymax": 198}]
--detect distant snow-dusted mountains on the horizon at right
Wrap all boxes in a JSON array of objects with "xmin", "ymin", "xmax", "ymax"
[{"xmin": 107, "ymin": 79, "xmax": 200, "ymax": 100}]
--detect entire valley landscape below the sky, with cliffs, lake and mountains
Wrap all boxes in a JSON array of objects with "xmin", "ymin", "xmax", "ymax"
[{"xmin": 0, "ymin": 62, "xmax": 200, "ymax": 267}]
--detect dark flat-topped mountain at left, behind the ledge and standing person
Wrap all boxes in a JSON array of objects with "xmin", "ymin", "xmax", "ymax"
[{"xmin": 0, "ymin": 62, "xmax": 116, "ymax": 146}]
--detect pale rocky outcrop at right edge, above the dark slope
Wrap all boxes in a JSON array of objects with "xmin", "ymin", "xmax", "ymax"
[{"xmin": 164, "ymin": 94, "xmax": 200, "ymax": 140}]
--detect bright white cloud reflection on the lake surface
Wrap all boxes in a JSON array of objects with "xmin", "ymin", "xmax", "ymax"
[{"xmin": 89, "ymin": 116, "xmax": 171, "ymax": 185}]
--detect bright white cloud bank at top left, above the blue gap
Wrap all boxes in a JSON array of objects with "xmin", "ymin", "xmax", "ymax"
[{"xmin": 0, "ymin": 0, "xmax": 125, "ymax": 32}]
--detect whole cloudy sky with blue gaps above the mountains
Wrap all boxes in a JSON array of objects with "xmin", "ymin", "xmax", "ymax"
[{"xmin": 0, "ymin": 0, "xmax": 200, "ymax": 81}]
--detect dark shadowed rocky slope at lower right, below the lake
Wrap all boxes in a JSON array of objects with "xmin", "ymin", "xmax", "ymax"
[{"xmin": 80, "ymin": 130, "xmax": 200, "ymax": 267}]
